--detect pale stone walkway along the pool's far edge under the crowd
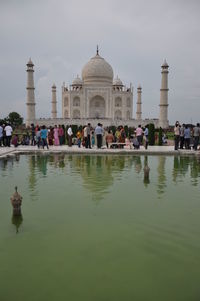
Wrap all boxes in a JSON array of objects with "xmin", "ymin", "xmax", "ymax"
[{"xmin": 0, "ymin": 145, "xmax": 200, "ymax": 158}]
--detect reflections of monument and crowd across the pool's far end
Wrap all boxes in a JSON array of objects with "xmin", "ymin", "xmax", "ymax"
[{"xmin": 0, "ymin": 153, "xmax": 200, "ymax": 200}]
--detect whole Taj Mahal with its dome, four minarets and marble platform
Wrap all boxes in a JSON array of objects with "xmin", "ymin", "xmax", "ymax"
[{"xmin": 26, "ymin": 47, "xmax": 169, "ymax": 128}]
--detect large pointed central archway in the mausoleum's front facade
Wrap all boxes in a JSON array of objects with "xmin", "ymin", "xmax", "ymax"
[{"xmin": 89, "ymin": 95, "xmax": 106, "ymax": 118}]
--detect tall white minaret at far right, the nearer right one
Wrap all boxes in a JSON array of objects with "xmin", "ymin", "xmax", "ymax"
[{"xmin": 159, "ymin": 60, "xmax": 169, "ymax": 129}]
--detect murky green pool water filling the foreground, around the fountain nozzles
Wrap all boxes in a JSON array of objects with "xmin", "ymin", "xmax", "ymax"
[{"xmin": 0, "ymin": 154, "xmax": 200, "ymax": 301}]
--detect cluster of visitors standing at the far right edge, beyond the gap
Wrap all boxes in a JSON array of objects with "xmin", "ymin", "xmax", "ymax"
[{"xmin": 174, "ymin": 121, "xmax": 200, "ymax": 151}]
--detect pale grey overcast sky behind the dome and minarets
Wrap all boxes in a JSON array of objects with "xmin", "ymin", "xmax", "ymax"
[{"xmin": 0, "ymin": 0, "xmax": 200, "ymax": 124}]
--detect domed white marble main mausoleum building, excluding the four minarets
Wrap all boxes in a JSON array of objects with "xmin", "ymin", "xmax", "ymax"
[{"xmin": 62, "ymin": 50, "xmax": 133, "ymax": 120}]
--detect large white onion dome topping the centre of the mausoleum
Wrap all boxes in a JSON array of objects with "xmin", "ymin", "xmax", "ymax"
[{"xmin": 82, "ymin": 52, "xmax": 113, "ymax": 84}]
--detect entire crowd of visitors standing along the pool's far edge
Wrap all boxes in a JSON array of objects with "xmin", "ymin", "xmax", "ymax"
[{"xmin": 0, "ymin": 121, "xmax": 200, "ymax": 150}]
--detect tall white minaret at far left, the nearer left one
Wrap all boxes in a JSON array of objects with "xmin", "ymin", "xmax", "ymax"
[{"xmin": 26, "ymin": 59, "xmax": 35, "ymax": 125}]
